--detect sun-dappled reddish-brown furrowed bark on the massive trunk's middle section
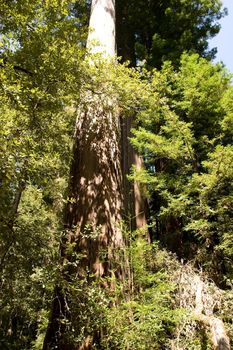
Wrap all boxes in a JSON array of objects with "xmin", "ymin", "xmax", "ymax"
[{"xmin": 64, "ymin": 96, "xmax": 122, "ymax": 276}]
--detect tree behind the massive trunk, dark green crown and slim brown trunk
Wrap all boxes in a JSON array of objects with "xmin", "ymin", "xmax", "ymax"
[{"xmin": 116, "ymin": 0, "xmax": 226, "ymax": 235}]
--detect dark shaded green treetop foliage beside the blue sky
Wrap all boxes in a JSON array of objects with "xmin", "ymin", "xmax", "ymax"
[{"xmin": 118, "ymin": 0, "xmax": 227, "ymax": 68}]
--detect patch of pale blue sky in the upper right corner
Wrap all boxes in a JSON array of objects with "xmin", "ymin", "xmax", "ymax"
[{"xmin": 209, "ymin": 0, "xmax": 233, "ymax": 73}]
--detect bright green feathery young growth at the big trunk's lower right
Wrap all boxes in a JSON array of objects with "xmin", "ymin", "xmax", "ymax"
[{"xmin": 101, "ymin": 231, "xmax": 182, "ymax": 350}]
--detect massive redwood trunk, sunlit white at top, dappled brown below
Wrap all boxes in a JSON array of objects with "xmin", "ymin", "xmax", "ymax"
[{"xmin": 43, "ymin": 0, "xmax": 123, "ymax": 350}]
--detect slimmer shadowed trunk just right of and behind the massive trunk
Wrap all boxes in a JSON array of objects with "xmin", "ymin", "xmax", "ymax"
[{"xmin": 116, "ymin": 1, "xmax": 149, "ymax": 235}]
